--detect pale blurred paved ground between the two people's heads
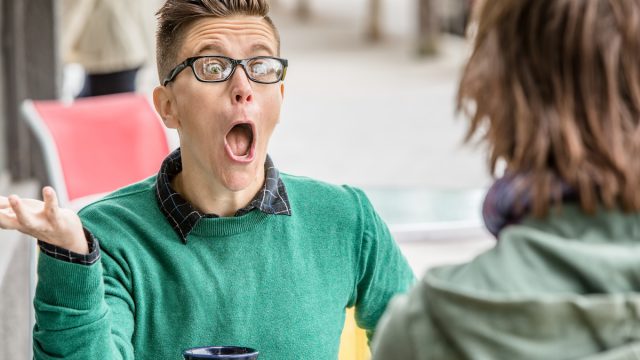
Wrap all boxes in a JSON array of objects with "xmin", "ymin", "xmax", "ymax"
[{"xmin": 264, "ymin": 4, "xmax": 489, "ymax": 189}]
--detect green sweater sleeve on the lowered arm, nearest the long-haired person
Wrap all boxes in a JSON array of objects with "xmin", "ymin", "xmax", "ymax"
[{"xmin": 353, "ymin": 190, "xmax": 415, "ymax": 340}]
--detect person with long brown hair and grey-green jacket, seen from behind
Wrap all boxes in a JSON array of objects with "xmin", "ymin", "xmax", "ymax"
[{"xmin": 372, "ymin": 0, "xmax": 640, "ymax": 360}]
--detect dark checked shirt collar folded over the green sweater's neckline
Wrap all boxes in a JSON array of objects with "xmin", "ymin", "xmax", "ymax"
[{"xmin": 156, "ymin": 149, "xmax": 291, "ymax": 243}]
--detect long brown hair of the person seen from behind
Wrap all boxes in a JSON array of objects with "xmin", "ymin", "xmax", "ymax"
[{"xmin": 457, "ymin": 0, "xmax": 640, "ymax": 216}]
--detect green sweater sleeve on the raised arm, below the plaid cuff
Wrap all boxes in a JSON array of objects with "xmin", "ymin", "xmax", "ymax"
[{"xmin": 33, "ymin": 238, "xmax": 134, "ymax": 360}]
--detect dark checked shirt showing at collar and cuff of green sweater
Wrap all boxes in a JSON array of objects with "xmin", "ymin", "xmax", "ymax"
[{"xmin": 38, "ymin": 149, "xmax": 291, "ymax": 265}]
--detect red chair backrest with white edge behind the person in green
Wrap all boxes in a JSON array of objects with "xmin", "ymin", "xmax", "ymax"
[{"xmin": 22, "ymin": 93, "xmax": 169, "ymax": 206}]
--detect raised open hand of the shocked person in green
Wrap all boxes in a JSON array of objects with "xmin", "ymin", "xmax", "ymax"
[{"xmin": 0, "ymin": 186, "xmax": 89, "ymax": 254}]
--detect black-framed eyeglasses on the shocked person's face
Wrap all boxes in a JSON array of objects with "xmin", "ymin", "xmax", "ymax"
[{"xmin": 162, "ymin": 55, "xmax": 289, "ymax": 86}]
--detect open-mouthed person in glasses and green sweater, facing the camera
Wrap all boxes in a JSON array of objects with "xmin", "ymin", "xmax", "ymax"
[{"xmin": 0, "ymin": 0, "xmax": 414, "ymax": 360}]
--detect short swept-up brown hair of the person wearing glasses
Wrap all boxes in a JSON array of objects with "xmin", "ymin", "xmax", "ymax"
[{"xmin": 156, "ymin": 0, "xmax": 280, "ymax": 82}]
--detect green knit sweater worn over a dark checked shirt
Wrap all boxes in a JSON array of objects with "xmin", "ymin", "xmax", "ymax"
[{"xmin": 34, "ymin": 175, "xmax": 413, "ymax": 360}]
